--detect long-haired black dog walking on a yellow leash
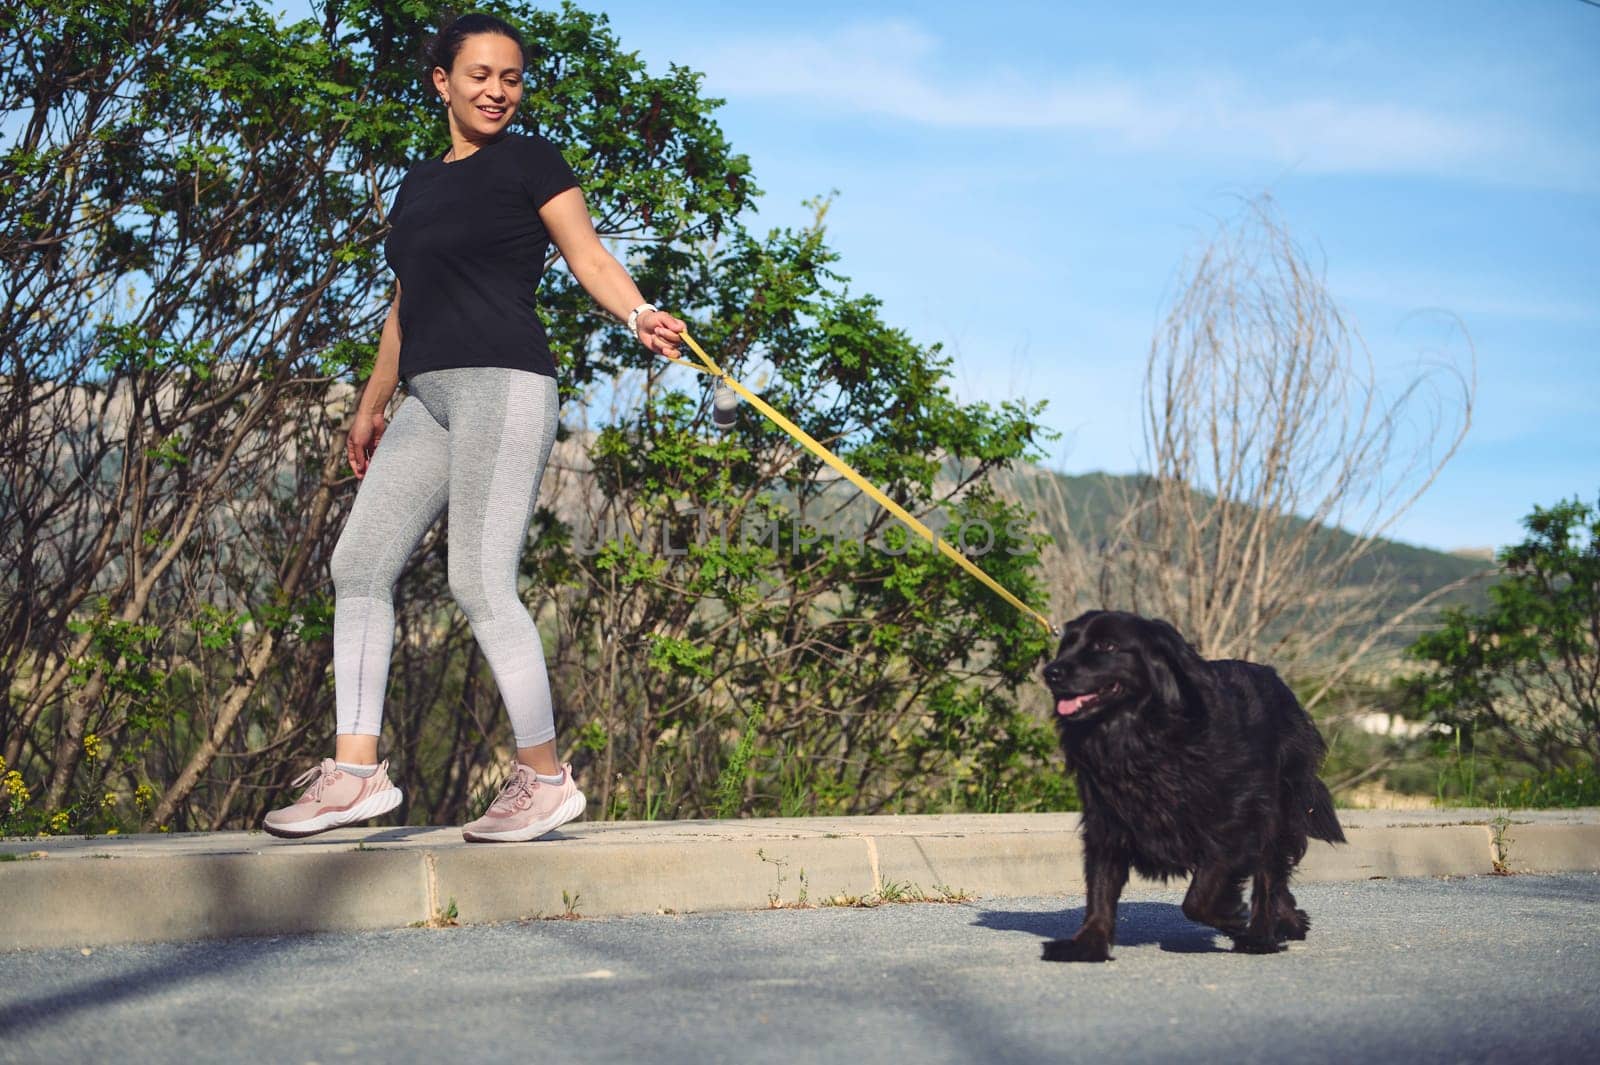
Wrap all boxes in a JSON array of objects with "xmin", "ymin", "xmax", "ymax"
[{"xmin": 1045, "ymin": 611, "xmax": 1344, "ymax": 961}]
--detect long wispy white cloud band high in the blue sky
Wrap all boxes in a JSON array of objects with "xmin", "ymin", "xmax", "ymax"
[{"xmin": 698, "ymin": 19, "xmax": 1600, "ymax": 189}]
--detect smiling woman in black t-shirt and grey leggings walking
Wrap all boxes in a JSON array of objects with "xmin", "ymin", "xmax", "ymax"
[{"xmin": 262, "ymin": 14, "xmax": 683, "ymax": 841}]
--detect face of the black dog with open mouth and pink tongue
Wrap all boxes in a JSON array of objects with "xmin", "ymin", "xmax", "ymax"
[{"xmin": 1045, "ymin": 611, "xmax": 1149, "ymax": 723}]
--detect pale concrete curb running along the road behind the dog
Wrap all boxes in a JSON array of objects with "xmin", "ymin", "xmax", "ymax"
[{"xmin": 0, "ymin": 809, "xmax": 1600, "ymax": 951}]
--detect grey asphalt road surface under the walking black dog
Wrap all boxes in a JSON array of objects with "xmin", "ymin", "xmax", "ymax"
[{"xmin": 0, "ymin": 875, "xmax": 1600, "ymax": 1065}]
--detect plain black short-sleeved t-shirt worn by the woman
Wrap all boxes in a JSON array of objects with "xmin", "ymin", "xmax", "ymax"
[{"xmin": 384, "ymin": 133, "xmax": 578, "ymax": 377}]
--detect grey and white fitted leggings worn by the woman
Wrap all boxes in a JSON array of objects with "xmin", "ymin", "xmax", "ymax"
[{"xmin": 331, "ymin": 366, "xmax": 558, "ymax": 747}]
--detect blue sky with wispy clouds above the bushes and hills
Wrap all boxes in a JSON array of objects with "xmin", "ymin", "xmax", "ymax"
[{"xmin": 294, "ymin": 0, "xmax": 1600, "ymax": 548}]
